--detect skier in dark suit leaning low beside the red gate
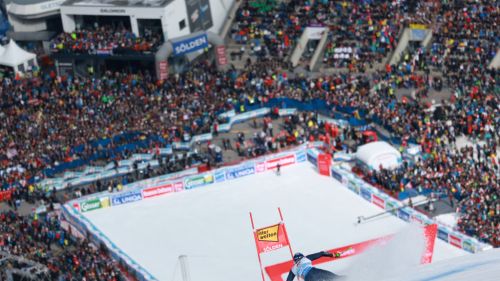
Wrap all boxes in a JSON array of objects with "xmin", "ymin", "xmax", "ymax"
[{"xmin": 286, "ymin": 251, "xmax": 340, "ymax": 281}]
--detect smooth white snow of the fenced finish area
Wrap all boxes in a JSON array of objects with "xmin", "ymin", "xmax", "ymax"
[{"xmin": 84, "ymin": 163, "xmax": 467, "ymax": 281}]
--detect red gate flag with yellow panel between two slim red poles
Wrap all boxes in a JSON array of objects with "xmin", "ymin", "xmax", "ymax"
[{"xmin": 254, "ymin": 223, "xmax": 289, "ymax": 254}]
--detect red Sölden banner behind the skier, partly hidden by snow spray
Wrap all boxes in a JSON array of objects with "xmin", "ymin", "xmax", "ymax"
[{"xmin": 265, "ymin": 224, "xmax": 437, "ymax": 281}]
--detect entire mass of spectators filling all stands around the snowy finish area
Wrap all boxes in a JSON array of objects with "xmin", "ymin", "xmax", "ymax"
[{"xmin": 0, "ymin": 0, "xmax": 500, "ymax": 281}]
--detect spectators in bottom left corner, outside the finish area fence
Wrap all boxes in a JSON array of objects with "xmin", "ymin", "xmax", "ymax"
[{"xmin": 0, "ymin": 211, "xmax": 126, "ymax": 281}]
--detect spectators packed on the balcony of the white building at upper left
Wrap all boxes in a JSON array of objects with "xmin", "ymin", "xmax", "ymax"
[{"xmin": 51, "ymin": 25, "xmax": 163, "ymax": 55}]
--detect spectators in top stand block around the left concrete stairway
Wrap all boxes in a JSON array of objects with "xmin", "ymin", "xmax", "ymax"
[{"xmin": 232, "ymin": 0, "xmax": 406, "ymax": 72}]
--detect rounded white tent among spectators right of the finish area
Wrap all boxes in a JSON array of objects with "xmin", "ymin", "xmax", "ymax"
[{"xmin": 356, "ymin": 141, "xmax": 402, "ymax": 171}]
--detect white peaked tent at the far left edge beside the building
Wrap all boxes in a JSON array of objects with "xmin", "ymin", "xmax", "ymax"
[{"xmin": 0, "ymin": 39, "xmax": 37, "ymax": 73}]
